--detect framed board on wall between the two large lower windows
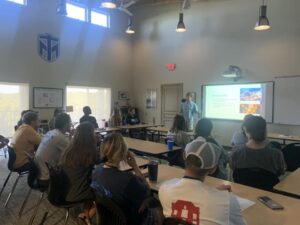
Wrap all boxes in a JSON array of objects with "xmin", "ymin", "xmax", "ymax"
[{"xmin": 33, "ymin": 87, "xmax": 64, "ymax": 108}]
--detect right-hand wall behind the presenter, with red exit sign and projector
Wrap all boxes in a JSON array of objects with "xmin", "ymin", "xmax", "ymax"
[{"xmin": 133, "ymin": 0, "xmax": 300, "ymax": 145}]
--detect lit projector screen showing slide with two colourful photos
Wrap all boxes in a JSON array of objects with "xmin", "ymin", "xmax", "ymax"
[{"xmin": 202, "ymin": 82, "xmax": 274, "ymax": 122}]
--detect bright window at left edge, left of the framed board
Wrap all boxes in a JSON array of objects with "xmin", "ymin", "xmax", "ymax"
[{"xmin": 0, "ymin": 83, "xmax": 29, "ymax": 137}]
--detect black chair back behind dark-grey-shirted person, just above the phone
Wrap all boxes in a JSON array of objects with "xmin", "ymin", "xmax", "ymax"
[{"xmin": 233, "ymin": 168, "xmax": 279, "ymax": 191}]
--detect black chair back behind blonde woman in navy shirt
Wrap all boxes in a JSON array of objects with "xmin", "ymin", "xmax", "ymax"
[{"xmin": 95, "ymin": 191, "xmax": 127, "ymax": 225}]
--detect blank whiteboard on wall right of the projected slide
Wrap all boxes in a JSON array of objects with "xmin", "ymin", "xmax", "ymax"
[{"xmin": 274, "ymin": 76, "xmax": 300, "ymax": 125}]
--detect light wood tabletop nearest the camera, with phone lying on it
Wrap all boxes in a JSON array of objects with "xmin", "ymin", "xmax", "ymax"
[{"xmin": 149, "ymin": 165, "xmax": 300, "ymax": 225}]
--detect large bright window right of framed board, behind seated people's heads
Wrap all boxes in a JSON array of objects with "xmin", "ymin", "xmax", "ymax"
[{"xmin": 67, "ymin": 86, "xmax": 111, "ymax": 127}]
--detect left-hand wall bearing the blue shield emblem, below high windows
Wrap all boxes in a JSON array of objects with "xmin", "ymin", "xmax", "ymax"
[{"xmin": 0, "ymin": 0, "xmax": 132, "ymax": 118}]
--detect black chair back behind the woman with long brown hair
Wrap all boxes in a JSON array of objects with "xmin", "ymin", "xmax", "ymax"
[{"xmin": 46, "ymin": 163, "xmax": 67, "ymax": 207}]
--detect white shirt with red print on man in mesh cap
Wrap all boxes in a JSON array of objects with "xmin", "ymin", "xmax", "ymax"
[{"xmin": 159, "ymin": 178, "xmax": 246, "ymax": 225}]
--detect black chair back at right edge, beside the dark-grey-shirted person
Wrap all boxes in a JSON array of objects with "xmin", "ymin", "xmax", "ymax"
[{"xmin": 282, "ymin": 143, "xmax": 300, "ymax": 171}]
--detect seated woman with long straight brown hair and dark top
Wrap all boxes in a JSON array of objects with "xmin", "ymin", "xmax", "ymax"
[{"xmin": 60, "ymin": 122, "xmax": 99, "ymax": 224}]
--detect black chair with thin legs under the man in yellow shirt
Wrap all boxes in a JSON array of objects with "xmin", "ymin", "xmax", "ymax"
[{"xmin": 0, "ymin": 146, "xmax": 29, "ymax": 207}]
